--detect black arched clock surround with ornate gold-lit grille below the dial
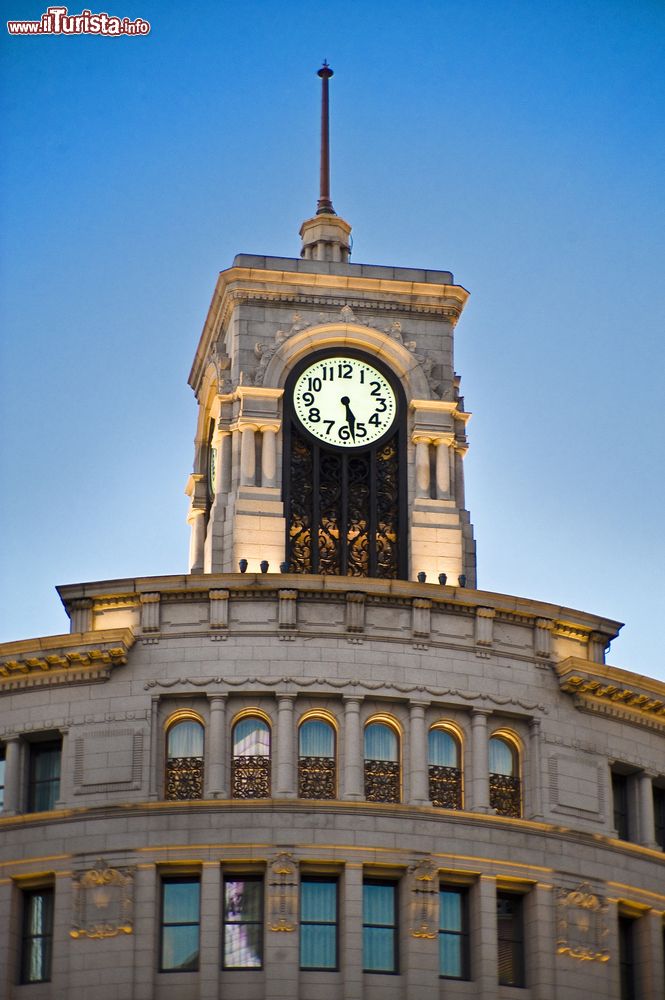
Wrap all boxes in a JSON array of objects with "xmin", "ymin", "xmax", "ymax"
[{"xmin": 282, "ymin": 344, "xmax": 408, "ymax": 579}]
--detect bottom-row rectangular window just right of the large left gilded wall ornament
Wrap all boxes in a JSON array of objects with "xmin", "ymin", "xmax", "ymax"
[{"xmin": 159, "ymin": 876, "xmax": 201, "ymax": 972}]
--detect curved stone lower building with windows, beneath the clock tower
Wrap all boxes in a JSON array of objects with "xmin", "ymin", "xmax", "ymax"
[{"xmin": 0, "ymin": 574, "xmax": 665, "ymax": 1000}]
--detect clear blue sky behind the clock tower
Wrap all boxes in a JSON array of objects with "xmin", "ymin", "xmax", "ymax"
[{"xmin": 0, "ymin": 0, "xmax": 665, "ymax": 678}]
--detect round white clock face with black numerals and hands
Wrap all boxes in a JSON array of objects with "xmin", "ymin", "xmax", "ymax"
[{"xmin": 293, "ymin": 355, "xmax": 397, "ymax": 448}]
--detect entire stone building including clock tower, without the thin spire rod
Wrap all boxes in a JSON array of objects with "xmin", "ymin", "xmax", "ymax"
[{"xmin": 0, "ymin": 92, "xmax": 665, "ymax": 1000}]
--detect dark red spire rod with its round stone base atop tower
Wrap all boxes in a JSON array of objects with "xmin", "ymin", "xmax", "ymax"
[{"xmin": 300, "ymin": 59, "xmax": 351, "ymax": 264}]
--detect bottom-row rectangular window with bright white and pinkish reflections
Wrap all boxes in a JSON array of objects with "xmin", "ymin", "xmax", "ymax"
[{"xmin": 222, "ymin": 875, "xmax": 263, "ymax": 969}]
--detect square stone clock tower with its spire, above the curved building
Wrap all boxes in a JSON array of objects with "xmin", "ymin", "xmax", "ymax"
[{"xmin": 187, "ymin": 64, "xmax": 476, "ymax": 587}]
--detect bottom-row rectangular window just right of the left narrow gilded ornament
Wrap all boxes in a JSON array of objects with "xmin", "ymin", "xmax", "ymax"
[{"xmin": 300, "ymin": 876, "xmax": 337, "ymax": 970}]
